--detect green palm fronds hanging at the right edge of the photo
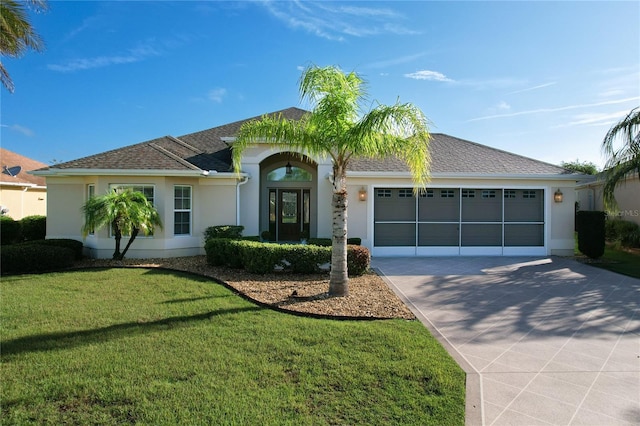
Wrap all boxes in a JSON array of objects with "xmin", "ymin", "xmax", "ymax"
[{"xmin": 602, "ymin": 107, "xmax": 640, "ymax": 210}]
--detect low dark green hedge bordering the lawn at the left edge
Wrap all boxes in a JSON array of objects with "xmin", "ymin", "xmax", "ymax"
[{"xmin": 0, "ymin": 244, "xmax": 75, "ymax": 274}]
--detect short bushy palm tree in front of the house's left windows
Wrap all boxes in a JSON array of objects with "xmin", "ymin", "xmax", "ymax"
[{"xmin": 82, "ymin": 189, "xmax": 162, "ymax": 260}]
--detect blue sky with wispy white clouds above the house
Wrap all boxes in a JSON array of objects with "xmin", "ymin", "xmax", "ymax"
[{"xmin": 0, "ymin": 1, "xmax": 640, "ymax": 170}]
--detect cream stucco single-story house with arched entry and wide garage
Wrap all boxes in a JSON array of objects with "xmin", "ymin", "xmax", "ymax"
[{"xmin": 35, "ymin": 108, "xmax": 581, "ymax": 258}]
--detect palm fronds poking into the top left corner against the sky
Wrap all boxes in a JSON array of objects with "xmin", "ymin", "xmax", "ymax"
[{"xmin": 0, "ymin": 0, "xmax": 48, "ymax": 93}]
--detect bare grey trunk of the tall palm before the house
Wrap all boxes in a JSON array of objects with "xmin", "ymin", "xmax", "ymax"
[{"xmin": 329, "ymin": 165, "xmax": 349, "ymax": 297}]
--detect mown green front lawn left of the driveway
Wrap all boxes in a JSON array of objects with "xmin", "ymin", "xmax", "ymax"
[{"xmin": 0, "ymin": 269, "xmax": 465, "ymax": 425}]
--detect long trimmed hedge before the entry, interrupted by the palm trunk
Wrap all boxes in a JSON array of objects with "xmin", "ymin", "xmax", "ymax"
[{"xmin": 205, "ymin": 238, "xmax": 371, "ymax": 276}]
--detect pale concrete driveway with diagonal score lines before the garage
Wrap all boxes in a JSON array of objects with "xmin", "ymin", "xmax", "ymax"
[{"xmin": 372, "ymin": 257, "xmax": 640, "ymax": 425}]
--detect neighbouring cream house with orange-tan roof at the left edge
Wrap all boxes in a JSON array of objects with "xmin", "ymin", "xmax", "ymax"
[{"xmin": 0, "ymin": 148, "xmax": 47, "ymax": 220}]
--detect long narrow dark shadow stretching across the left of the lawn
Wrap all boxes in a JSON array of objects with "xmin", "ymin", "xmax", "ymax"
[{"xmin": 0, "ymin": 306, "xmax": 264, "ymax": 361}]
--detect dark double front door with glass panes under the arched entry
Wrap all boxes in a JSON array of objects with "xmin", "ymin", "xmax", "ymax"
[{"xmin": 269, "ymin": 188, "xmax": 311, "ymax": 242}]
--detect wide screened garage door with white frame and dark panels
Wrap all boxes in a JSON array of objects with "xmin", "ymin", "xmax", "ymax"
[{"xmin": 373, "ymin": 188, "xmax": 546, "ymax": 256}]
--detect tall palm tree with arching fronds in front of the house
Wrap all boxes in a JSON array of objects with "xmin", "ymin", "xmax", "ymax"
[{"xmin": 233, "ymin": 66, "xmax": 430, "ymax": 296}]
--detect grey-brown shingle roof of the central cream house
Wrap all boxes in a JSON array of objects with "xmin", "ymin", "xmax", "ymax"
[{"xmin": 35, "ymin": 108, "xmax": 572, "ymax": 180}]
